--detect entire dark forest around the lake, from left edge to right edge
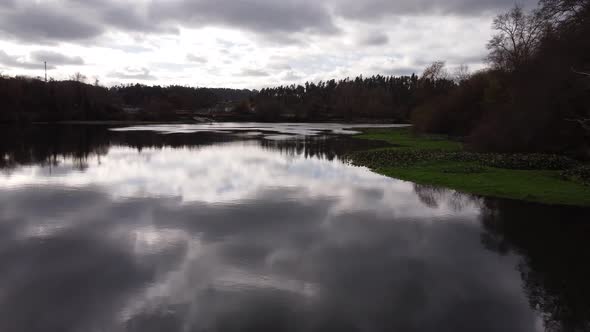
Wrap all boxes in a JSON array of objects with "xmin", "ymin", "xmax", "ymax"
[{"xmin": 0, "ymin": 0, "xmax": 590, "ymax": 154}]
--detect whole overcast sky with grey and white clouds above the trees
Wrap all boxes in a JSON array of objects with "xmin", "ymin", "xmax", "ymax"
[{"xmin": 0, "ymin": 0, "xmax": 535, "ymax": 89}]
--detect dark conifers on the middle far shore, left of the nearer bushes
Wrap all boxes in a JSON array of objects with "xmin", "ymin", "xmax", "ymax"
[{"xmin": 255, "ymin": 66, "xmax": 464, "ymax": 122}]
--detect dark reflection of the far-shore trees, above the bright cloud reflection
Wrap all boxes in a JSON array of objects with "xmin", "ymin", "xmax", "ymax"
[{"xmin": 0, "ymin": 125, "xmax": 383, "ymax": 171}]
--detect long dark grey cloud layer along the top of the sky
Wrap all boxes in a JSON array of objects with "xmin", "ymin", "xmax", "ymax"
[{"xmin": 0, "ymin": 0, "xmax": 535, "ymax": 45}]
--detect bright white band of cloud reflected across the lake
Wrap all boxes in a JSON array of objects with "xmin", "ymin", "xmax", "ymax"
[{"xmin": 0, "ymin": 142, "xmax": 477, "ymax": 217}]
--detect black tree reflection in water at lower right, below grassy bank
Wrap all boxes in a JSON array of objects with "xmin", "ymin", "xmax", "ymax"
[{"xmin": 482, "ymin": 200, "xmax": 590, "ymax": 331}]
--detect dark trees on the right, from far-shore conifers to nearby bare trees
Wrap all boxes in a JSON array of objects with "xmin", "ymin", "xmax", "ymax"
[{"xmin": 255, "ymin": 0, "xmax": 590, "ymax": 158}]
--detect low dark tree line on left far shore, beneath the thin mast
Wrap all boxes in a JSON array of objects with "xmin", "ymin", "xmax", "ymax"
[{"xmin": 0, "ymin": 74, "xmax": 254, "ymax": 123}]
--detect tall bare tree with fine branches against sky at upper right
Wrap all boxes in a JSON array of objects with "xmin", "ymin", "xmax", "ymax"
[{"xmin": 487, "ymin": 5, "xmax": 546, "ymax": 70}]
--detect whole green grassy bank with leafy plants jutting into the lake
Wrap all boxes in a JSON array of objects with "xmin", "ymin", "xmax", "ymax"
[{"xmin": 350, "ymin": 128, "xmax": 590, "ymax": 206}]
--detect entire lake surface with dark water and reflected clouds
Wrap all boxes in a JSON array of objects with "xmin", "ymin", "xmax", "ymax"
[{"xmin": 0, "ymin": 126, "xmax": 590, "ymax": 332}]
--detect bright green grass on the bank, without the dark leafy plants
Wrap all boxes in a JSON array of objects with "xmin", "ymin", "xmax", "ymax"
[{"xmin": 353, "ymin": 128, "xmax": 590, "ymax": 206}]
